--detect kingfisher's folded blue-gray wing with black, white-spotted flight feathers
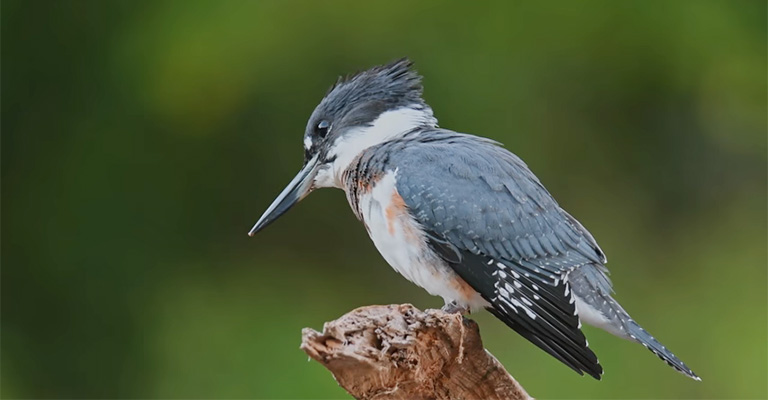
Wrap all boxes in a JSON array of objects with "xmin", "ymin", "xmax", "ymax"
[{"xmin": 386, "ymin": 131, "xmax": 605, "ymax": 379}]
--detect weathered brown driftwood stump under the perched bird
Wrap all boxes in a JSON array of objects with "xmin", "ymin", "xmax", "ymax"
[{"xmin": 301, "ymin": 304, "xmax": 530, "ymax": 400}]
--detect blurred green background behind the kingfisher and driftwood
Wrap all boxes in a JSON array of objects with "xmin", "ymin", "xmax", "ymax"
[{"xmin": 0, "ymin": 0, "xmax": 768, "ymax": 398}]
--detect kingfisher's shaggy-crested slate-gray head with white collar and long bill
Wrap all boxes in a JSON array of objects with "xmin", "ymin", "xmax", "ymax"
[{"xmin": 249, "ymin": 58, "xmax": 437, "ymax": 235}]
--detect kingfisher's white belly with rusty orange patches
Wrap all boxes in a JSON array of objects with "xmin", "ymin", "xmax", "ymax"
[{"xmin": 358, "ymin": 171, "xmax": 488, "ymax": 310}]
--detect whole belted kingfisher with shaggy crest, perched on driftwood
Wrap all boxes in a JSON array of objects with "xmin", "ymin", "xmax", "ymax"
[{"xmin": 249, "ymin": 59, "xmax": 700, "ymax": 380}]
